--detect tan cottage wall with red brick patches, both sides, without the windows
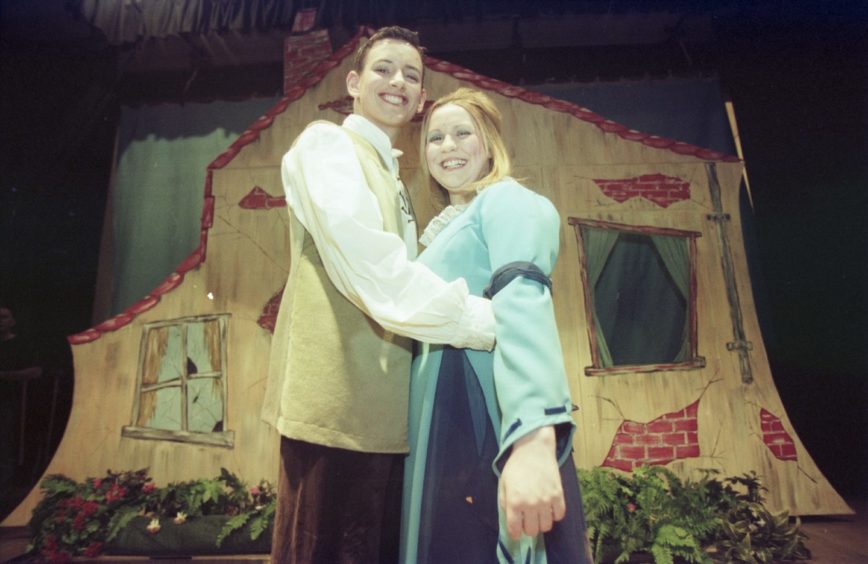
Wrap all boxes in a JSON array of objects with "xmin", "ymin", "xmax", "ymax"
[{"xmin": 3, "ymin": 32, "xmax": 851, "ymax": 525}]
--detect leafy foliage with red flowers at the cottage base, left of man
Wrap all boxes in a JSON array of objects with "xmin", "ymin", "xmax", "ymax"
[{"xmin": 28, "ymin": 468, "xmax": 276, "ymax": 562}]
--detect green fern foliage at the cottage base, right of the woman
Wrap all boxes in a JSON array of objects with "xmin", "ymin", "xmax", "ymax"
[{"xmin": 579, "ymin": 466, "xmax": 810, "ymax": 564}]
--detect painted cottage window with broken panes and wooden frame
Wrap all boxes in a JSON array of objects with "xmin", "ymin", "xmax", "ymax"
[{"xmin": 123, "ymin": 315, "xmax": 233, "ymax": 447}]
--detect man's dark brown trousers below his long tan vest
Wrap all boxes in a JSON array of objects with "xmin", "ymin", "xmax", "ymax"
[{"xmin": 271, "ymin": 437, "xmax": 404, "ymax": 564}]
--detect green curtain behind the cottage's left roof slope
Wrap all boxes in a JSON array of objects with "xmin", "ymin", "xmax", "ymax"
[{"xmin": 101, "ymin": 98, "xmax": 277, "ymax": 317}]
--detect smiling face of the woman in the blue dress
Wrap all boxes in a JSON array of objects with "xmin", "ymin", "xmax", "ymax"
[{"xmin": 425, "ymin": 104, "xmax": 491, "ymax": 204}]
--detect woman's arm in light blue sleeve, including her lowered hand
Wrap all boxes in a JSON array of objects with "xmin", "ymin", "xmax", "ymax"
[{"xmin": 480, "ymin": 182, "xmax": 574, "ymax": 538}]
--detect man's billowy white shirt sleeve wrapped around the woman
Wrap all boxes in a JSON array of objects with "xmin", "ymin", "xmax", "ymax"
[{"xmin": 281, "ymin": 124, "xmax": 494, "ymax": 350}]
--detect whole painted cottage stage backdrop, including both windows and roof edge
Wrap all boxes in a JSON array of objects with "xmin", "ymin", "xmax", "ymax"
[{"xmin": 3, "ymin": 27, "xmax": 852, "ymax": 525}]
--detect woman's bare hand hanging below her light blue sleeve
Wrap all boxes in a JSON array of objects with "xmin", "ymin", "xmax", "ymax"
[{"xmin": 498, "ymin": 426, "xmax": 566, "ymax": 539}]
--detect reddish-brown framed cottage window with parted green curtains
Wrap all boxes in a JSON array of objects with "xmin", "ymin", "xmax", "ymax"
[{"xmin": 570, "ymin": 218, "xmax": 704, "ymax": 375}]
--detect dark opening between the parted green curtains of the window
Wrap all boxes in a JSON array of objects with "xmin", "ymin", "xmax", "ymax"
[{"xmin": 594, "ymin": 232, "xmax": 688, "ymax": 366}]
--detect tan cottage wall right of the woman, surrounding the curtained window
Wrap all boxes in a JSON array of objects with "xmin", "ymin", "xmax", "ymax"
[{"xmin": 413, "ymin": 67, "xmax": 852, "ymax": 514}]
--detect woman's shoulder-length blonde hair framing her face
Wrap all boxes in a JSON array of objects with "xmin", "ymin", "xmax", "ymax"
[{"xmin": 420, "ymin": 87, "xmax": 512, "ymax": 209}]
